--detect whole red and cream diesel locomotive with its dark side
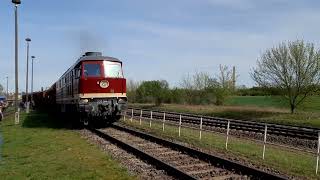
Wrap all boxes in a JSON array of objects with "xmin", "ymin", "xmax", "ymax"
[{"xmin": 55, "ymin": 52, "xmax": 127, "ymax": 125}]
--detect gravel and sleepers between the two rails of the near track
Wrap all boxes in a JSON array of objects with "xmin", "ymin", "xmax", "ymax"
[{"xmin": 103, "ymin": 128, "xmax": 249, "ymax": 179}]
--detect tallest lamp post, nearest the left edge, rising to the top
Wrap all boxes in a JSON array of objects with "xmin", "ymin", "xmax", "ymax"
[{"xmin": 12, "ymin": 0, "xmax": 21, "ymax": 114}]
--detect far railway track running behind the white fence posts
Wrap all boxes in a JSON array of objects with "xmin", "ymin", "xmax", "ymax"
[{"xmin": 126, "ymin": 108, "xmax": 320, "ymax": 140}]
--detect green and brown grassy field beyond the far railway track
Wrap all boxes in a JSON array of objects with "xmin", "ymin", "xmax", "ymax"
[{"xmin": 131, "ymin": 96, "xmax": 320, "ymax": 128}]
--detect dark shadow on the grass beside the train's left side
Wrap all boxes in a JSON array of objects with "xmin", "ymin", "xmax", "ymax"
[{"xmin": 22, "ymin": 111, "xmax": 80, "ymax": 129}]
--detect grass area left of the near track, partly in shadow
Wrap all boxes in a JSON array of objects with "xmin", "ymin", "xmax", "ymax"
[{"xmin": 0, "ymin": 113, "xmax": 135, "ymax": 179}]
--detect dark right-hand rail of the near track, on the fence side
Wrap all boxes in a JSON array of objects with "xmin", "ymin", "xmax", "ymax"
[{"xmin": 112, "ymin": 124, "xmax": 288, "ymax": 179}]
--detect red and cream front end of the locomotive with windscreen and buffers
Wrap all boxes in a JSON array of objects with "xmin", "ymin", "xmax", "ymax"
[{"xmin": 79, "ymin": 52, "xmax": 127, "ymax": 122}]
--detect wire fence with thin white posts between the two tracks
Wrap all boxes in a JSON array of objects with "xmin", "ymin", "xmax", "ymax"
[{"xmin": 123, "ymin": 109, "xmax": 320, "ymax": 174}]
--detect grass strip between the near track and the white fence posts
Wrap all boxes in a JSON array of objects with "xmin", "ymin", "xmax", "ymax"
[{"xmin": 122, "ymin": 117, "xmax": 320, "ymax": 179}]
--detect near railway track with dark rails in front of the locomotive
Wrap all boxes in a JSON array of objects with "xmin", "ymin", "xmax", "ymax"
[{"xmin": 90, "ymin": 125, "xmax": 286, "ymax": 179}]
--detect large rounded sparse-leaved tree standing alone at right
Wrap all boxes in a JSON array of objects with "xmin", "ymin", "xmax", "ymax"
[{"xmin": 251, "ymin": 40, "xmax": 320, "ymax": 113}]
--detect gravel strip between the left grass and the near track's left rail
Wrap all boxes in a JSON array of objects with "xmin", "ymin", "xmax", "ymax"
[{"xmin": 80, "ymin": 130, "xmax": 174, "ymax": 180}]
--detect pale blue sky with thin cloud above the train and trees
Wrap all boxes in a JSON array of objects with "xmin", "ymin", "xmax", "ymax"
[{"xmin": 0, "ymin": 0, "xmax": 320, "ymax": 91}]
